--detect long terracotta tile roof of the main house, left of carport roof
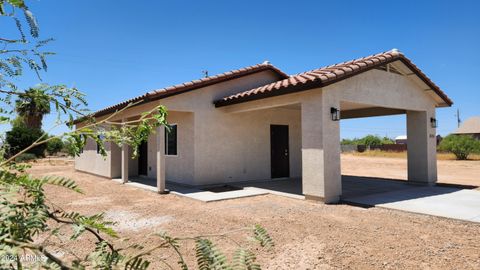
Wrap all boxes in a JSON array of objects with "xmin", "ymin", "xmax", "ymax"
[{"xmin": 74, "ymin": 62, "xmax": 288, "ymax": 123}]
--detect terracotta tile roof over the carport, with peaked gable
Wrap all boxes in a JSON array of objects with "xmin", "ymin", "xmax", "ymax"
[{"xmin": 214, "ymin": 49, "xmax": 453, "ymax": 107}]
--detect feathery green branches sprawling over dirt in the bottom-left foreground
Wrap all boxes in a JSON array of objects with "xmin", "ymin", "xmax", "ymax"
[{"xmin": 0, "ymin": 165, "xmax": 273, "ymax": 269}]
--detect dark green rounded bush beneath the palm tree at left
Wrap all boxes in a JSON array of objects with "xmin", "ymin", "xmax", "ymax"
[{"xmin": 5, "ymin": 124, "xmax": 47, "ymax": 157}]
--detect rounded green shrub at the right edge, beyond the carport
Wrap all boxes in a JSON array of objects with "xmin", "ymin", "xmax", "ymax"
[{"xmin": 438, "ymin": 134, "xmax": 480, "ymax": 160}]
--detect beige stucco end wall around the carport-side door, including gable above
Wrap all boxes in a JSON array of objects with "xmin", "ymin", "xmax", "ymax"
[{"xmin": 153, "ymin": 72, "xmax": 301, "ymax": 185}]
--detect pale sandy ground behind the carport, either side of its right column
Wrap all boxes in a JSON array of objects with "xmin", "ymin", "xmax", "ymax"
[{"xmin": 342, "ymin": 154, "xmax": 480, "ymax": 187}]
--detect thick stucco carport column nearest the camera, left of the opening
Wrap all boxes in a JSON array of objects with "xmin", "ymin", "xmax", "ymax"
[{"xmin": 302, "ymin": 92, "xmax": 342, "ymax": 203}]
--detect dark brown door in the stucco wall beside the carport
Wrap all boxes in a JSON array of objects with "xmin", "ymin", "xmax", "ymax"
[{"xmin": 270, "ymin": 125, "xmax": 290, "ymax": 178}]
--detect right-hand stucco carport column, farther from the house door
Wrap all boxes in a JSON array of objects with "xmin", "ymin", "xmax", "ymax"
[{"xmin": 407, "ymin": 107, "xmax": 437, "ymax": 185}]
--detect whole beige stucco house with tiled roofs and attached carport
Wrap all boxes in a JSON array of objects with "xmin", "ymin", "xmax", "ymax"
[{"xmin": 75, "ymin": 49, "xmax": 452, "ymax": 203}]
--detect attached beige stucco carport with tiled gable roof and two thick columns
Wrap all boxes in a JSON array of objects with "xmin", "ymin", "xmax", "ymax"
[{"xmin": 215, "ymin": 50, "xmax": 452, "ymax": 203}]
